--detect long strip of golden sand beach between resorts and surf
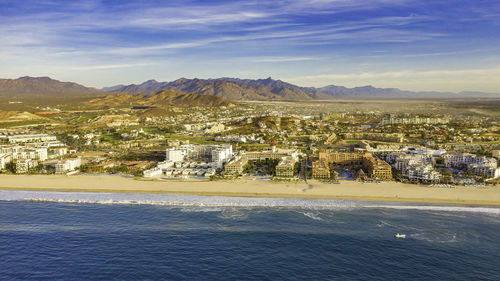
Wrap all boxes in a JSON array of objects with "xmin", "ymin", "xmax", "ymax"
[{"xmin": 0, "ymin": 175, "xmax": 500, "ymax": 206}]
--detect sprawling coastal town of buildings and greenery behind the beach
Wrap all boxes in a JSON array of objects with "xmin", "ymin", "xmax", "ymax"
[{"xmin": 0, "ymin": 98, "xmax": 500, "ymax": 186}]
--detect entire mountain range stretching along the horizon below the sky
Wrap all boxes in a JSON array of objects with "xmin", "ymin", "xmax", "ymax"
[{"xmin": 0, "ymin": 76, "xmax": 500, "ymax": 101}]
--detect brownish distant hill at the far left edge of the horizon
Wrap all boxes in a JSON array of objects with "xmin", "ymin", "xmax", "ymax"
[{"xmin": 0, "ymin": 76, "xmax": 104, "ymax": 97}]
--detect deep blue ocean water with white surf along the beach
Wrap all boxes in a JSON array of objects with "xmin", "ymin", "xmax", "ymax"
[{"xmin": 0, "ymin": 191, "xmax": 500, "ymax": 280}]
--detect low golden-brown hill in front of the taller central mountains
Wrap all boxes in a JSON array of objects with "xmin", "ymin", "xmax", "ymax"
[{"xmin": 84, "ymin": 90, "xmax": 235, "ymax": 108}]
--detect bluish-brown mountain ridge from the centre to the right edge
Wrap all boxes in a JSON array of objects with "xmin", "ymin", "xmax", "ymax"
[{"xmin": 103, "ymin": 77, "xmax": 500, "ymax": 101}]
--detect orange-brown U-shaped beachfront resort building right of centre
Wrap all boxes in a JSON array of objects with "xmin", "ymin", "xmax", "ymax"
[{"xmin": 312, "ymin": 151, "xmax": 392, "ymax": 180}]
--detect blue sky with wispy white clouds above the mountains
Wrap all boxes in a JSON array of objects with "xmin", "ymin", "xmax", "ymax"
[{"xmin": 0, "ymin": 0, "xmax": 500, "ymax": 93}]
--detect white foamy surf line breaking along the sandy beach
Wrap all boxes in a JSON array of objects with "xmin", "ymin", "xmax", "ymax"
[{"xmin": 0, "ymin": 190, "xmax": 500, "ymax": 215}]
